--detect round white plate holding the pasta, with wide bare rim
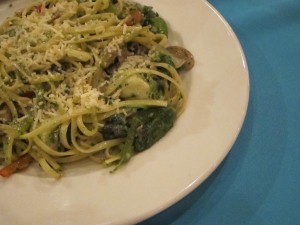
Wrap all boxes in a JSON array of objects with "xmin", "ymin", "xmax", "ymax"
[{"xmin": 0, "ymin": 0, "xmax": 249, "ymax": 225}]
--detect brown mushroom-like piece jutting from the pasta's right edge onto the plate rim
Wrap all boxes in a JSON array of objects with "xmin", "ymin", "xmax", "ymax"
[{"xmin": 166, "ymin": 46, "xmax": 195, "ymax": 70}]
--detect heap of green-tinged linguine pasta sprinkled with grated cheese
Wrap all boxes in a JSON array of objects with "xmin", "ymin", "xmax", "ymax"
[{"xmin": 0, "ymin": 0, "xmax": 192, "ymax": 178}]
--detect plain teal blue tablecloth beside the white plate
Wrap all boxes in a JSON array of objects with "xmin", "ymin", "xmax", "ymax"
[{"xmin": 140, "ymin": 0, "xmax": 300, "ymax": 225}]
